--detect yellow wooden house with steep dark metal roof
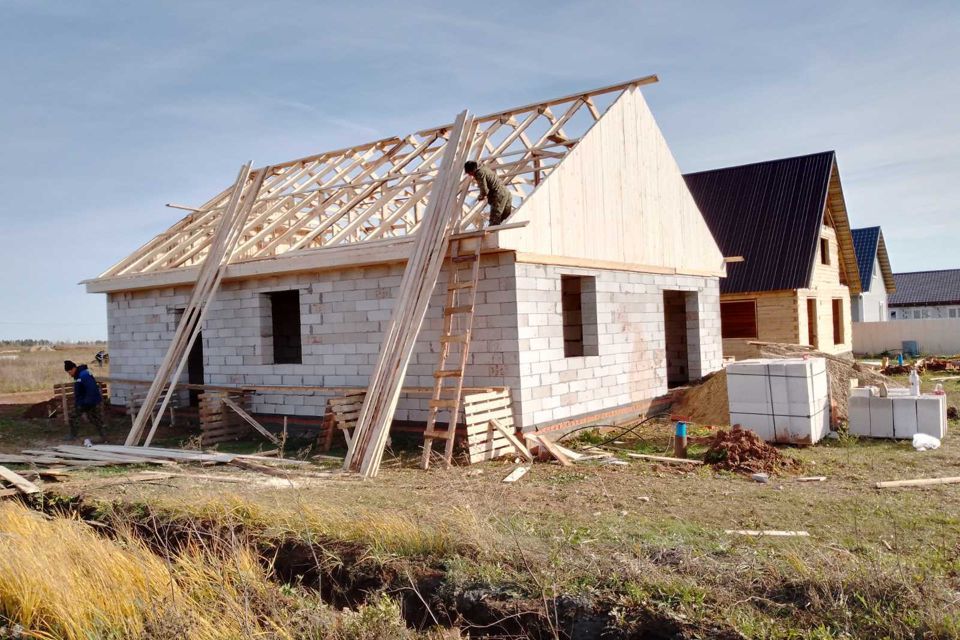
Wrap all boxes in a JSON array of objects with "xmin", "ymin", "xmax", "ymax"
[{"xmin": 684, "ymin": 151, "xmax": 860, "ymax": 358}]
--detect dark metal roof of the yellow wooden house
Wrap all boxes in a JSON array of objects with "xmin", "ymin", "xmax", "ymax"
[{"xmin": 684, "ymin": 151, "xmax": 835, "ymax": 293}]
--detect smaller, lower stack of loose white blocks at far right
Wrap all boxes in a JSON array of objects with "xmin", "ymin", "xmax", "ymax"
[{"xmin": 849, "ymin": 387, "xmax": 947, "ymax": 439}]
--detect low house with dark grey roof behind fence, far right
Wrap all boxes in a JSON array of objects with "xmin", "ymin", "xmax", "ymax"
[{"xmin": 888, "ymin": 269, "xmax": 960, "ymax": 320}]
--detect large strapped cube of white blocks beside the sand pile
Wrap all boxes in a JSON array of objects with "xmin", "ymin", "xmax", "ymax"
[{"xmin": 727, "ymin": 358, "xmax": 830, "ymax": 444}]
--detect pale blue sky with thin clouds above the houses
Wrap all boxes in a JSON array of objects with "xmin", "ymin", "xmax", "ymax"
[{"xmin": 0, "ymin": 0, "xmax": 960, "ymax": 339}]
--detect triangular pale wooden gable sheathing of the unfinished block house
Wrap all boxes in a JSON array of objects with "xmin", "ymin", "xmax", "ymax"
[{"xmin": 500, "ymin": 88, "xmax": 725, "ymax": 276}]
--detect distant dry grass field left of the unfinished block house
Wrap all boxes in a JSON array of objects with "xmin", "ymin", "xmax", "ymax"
[{"xmin": 0, "ymin": 343, "xmax": 109, "ymax": 395}]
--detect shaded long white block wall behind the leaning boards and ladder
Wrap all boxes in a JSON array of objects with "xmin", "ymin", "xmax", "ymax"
[{"xmin": 107, "ymin": 253, "xmax": 520, "ymax": 420}]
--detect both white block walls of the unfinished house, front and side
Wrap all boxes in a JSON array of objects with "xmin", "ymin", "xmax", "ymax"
[{"xmin": 108, "ymin": 253, "xmax": 722, "ymax": 429}]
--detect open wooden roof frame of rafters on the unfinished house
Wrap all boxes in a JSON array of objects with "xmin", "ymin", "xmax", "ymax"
[{"xmin": 100, "ymin": 76, "xmax": 657, "ymax": 278}]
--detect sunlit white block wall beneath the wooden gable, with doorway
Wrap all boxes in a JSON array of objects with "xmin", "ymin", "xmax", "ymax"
[{"xmin": 514, "ymin": 263, "xmax": 723, "ymax": 427}]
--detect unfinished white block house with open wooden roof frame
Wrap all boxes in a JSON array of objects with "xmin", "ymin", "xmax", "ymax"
[{"xmin": 86, "ymin": 80, "xmax": 725, "ymax": 429}]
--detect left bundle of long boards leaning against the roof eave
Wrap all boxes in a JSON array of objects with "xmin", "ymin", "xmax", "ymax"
[{"xmin": 126, "ymin": 162, "xmax": 269, "ymax": 446}]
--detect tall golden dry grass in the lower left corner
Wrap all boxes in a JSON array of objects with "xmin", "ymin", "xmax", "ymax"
[{"xmin": 0, "ymin": 503, "xmax": 438, "ymax": 640}]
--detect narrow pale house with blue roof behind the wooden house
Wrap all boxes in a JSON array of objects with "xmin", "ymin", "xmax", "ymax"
[{"xmin": 850, "ymin": 227, "xmax": 897, "ymax": 322}]
